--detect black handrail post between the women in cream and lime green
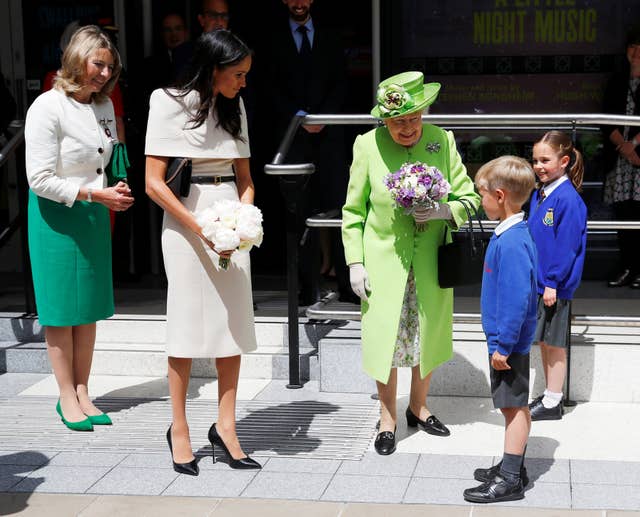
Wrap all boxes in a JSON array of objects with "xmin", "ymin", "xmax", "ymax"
[{"xmin": 264, "ymin": 160, "xmax": 315, "ymax": 389}]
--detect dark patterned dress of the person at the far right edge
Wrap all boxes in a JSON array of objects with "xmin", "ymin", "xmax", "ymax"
[{"xmin": 604, "ymin": 78, "xmax": 640, "ymax": 204}]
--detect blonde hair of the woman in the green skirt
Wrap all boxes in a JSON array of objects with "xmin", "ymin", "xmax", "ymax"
[{"xmin": 53, "ymin": 25, "xmax": 122, "ymax": 101}]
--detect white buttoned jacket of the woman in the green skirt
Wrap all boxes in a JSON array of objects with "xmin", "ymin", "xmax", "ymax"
[{"xmin": 24, "ymin": 88, "xmax": 117, "ymax": 206}]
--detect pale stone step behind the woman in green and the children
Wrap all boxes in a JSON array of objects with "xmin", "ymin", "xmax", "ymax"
[{"xmin": 318, "ymin": 322, "xmax": 640, "ymax": 403}]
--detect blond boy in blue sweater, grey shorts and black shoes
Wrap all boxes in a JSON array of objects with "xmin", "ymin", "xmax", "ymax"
[{"xmin": 464, "ymin": 156, "xmax": 537, "ymax": 503}]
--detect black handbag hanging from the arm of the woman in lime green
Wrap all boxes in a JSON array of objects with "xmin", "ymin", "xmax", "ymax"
[{"xmin": 438, "ymin": 199, "xmax": 490, "ymax": 289}]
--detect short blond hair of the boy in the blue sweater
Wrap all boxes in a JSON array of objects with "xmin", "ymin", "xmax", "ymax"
[{"xmin": 474, "ymin": 155, "xmax": 536, "ymax": 206}]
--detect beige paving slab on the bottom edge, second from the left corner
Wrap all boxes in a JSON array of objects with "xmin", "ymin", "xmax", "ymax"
[{"xmin": 79, "ymin": 495, "xmax": 220, "ymax": 517}]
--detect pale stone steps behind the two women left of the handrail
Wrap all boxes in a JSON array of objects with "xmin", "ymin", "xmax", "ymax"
[{"xmin": 0, "ymin": 314, "xmax": 336, "ymax": 380}]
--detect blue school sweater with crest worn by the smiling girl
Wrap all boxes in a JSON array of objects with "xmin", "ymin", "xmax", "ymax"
[{"xmin": 528, "ymin": 181, "xmax": 587, "ymax": 300}]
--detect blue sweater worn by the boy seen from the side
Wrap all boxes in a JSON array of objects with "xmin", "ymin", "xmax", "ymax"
[{"xmin": 480, "ymin": 221, "xmax": 537, "ymax": 355}]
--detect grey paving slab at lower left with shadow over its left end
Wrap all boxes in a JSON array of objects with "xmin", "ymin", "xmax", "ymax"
[{"xmin": 11, "ymin": 465, "xmax": 109, "ymax": 494}]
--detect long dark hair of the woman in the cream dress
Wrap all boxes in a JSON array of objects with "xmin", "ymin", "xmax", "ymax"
[{"xmin": 165, "ymin": 29, "xmax": 252, "ymax": 140}]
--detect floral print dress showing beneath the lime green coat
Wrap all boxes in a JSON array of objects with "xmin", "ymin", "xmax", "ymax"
[{"xmin": 391, "ymin": 268, "xmax": 420, "ymax": 368}]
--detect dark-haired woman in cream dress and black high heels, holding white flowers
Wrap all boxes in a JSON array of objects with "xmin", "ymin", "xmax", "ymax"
[{"xmin": 145, "ymin": 30, "xmax": 260, "ymax": 475}]
